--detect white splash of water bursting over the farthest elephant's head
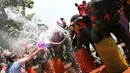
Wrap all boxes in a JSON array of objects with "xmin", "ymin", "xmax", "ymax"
[{"xmin": 39, "ymin": 25, "xmax": 65, "ymax": 43}]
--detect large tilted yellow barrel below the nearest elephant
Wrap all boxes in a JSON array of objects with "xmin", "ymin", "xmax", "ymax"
[{"xmin": 95, "ymin": 37, "xmax": 128, "ymax": 73}]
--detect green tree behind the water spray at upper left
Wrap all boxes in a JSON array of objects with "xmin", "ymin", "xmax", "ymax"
[{"xmin": 0, "ymin": 0, "xmax": 34, "ymax": 49}]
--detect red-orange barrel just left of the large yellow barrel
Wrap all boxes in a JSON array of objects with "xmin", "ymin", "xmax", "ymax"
[{"xmin": 74, "ymin": 48, "xmax": 94, "ymax": 72}]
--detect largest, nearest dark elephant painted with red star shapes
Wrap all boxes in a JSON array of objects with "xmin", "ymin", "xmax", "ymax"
[{"xmin": 86, "ymin": 0, "xmax": 130, "ymax": 57}]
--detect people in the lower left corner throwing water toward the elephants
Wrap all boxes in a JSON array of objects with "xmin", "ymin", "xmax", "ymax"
[{"xmin": 0, "ymin": 43, "xmax": 44, "ymax": 73}]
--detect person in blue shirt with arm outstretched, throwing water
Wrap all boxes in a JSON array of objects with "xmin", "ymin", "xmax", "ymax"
[{"xmin": 7, "ymin": 45, "xmax": 43, "ymax": 73}]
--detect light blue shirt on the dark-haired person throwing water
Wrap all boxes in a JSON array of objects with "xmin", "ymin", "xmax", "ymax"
[{"xmin": 8, "ymin": 61, "xmax": 20, "ymax": 73}]
